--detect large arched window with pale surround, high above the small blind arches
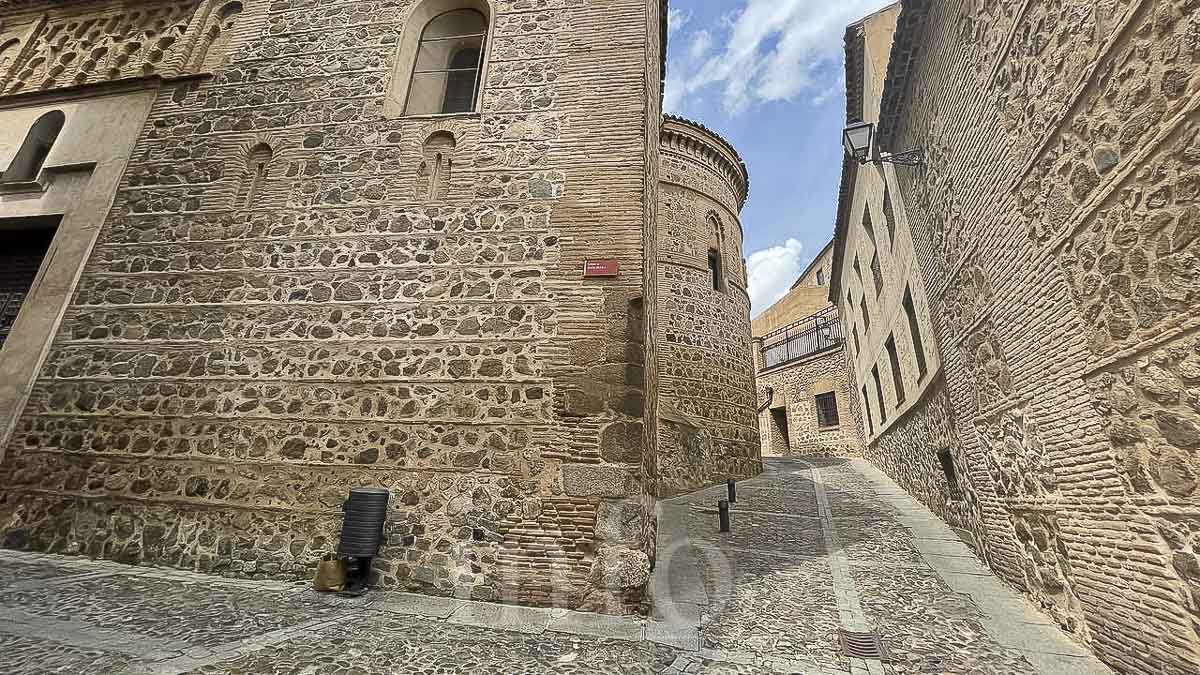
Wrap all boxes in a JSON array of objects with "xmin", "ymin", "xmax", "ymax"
[{"xmin": 404, "ymin": 10, "xmax": 487, "ymax": 115}]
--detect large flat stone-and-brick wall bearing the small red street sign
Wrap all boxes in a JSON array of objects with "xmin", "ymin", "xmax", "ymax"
[{"xmin": 0, "ymin": 0, "xmax": 757, "ymax": 611}]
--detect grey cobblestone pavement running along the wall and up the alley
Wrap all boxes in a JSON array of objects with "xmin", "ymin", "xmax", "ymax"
[{"xmin": 0, "ymin": 460, "xmax": 1108, "ymax": 675}]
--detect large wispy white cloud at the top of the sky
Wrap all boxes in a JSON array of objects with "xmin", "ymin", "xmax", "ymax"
[{"xmin": 668, "ymin": 0, "xmax": 890, "ymax": 115}]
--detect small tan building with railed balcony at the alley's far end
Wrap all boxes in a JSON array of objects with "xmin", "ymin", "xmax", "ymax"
[{"xmin": 751, "ymin": 243, "xmax": 863, "ymax": 456}]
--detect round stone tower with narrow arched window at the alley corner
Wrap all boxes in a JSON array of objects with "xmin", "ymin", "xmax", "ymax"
[{"xmin": 654, "ymin": 115, "xmax": 761, "ymax": 496}]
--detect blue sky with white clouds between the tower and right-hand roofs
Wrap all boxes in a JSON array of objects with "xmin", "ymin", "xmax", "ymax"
[{"xmin": 665, "ymin": 0, "xmax": 890, "ymax": 313}]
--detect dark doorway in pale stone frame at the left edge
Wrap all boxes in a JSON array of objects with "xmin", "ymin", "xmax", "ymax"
[{"xmin": 0, "ymin": 216, "xmax": 59, "ymax": 346}]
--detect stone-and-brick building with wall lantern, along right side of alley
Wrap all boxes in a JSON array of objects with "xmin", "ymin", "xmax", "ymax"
[{"xmin": 830, "ymin": 0, "xmax": 1200, "ymax": 674}]
